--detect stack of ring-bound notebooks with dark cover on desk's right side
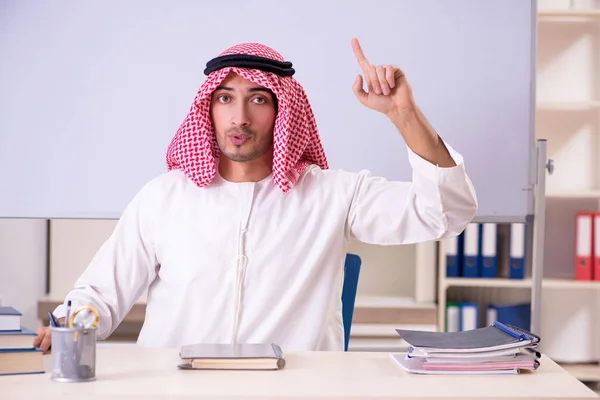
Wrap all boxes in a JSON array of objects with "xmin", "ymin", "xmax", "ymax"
[{"xmin": 391, "ymin": 321, "xmax": 541, "ymax": 375}]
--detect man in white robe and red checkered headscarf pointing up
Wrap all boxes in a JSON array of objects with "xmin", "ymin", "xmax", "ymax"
[{"xmin": 34, "ymin": 39, "xmax": 477, "ymax": 350}]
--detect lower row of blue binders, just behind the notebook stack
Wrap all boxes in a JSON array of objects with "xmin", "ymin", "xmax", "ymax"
[{"xmin": 445, "ymin": 302, "xmax": 531, "ymax": 332}]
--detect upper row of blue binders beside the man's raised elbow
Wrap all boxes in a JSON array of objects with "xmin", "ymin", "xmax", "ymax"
[{"xmin": 441, "ymin": 222, "xmax": 527, "ymax": 279}]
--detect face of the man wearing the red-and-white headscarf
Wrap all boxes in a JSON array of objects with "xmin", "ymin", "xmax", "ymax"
[{"xmin": 211, "ymin": 73, "xmax": 277, "ymax": 162}]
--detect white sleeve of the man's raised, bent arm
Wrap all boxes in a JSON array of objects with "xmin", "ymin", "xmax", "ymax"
[{"xmin": 347, "ymin": 139, "xmax": 478, "ymax": 245}]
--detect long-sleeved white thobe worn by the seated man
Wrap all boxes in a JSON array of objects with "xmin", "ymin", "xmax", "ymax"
[{"xmin": 55, "ymin": 146, "xmax": 477, "ymax": 350}]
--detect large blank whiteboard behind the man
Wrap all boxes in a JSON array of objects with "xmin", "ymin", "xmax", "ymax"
[{"xmin": 0, "ymin": 0, "xmax": 536, "ymax": 220}]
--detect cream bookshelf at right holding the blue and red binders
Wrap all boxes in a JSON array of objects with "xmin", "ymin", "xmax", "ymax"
[{"xmin": 437, "ymin": 0, "xmax": 600, "ymax": 381}]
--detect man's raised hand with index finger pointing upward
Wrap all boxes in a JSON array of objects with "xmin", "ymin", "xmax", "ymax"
[{"xmin": 352, "ymin": 38, "xmax": 416, "ymax": 116}]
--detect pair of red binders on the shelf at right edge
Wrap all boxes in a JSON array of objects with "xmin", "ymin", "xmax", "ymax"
[{"xmin": 575, "ymin": 211, "xmax": 600, "ymax": 281}]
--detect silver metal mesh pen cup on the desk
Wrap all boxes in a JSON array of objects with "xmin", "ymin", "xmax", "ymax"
[{"xmin": 50, "ymin": 327, "xmax": 96, "ymax": 382}]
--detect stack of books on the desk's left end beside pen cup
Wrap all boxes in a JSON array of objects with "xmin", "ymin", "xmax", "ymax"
[{"xmin": 0, "ymin": 307, "xmax": 44, "ymax": 376}]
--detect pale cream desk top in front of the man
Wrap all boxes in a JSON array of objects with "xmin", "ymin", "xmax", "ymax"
[{"xmin": 0, "ymin": 343, "xmax": 597, "ymax": 400}]
